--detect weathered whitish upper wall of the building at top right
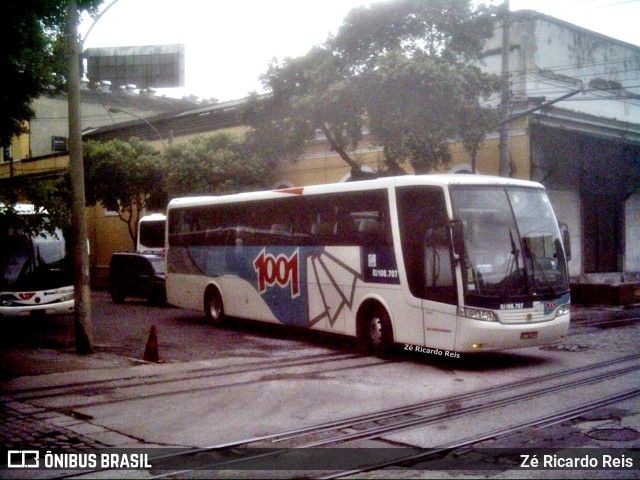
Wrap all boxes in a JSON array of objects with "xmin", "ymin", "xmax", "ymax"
[{"xmin": 485, "ymin": 11, "xmax": 640, "ymax": 124}]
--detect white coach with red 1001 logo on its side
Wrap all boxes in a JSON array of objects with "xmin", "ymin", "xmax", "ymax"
[{"xmin": 167, "ymin": 175, "xmax": 570, "ymax": 356}]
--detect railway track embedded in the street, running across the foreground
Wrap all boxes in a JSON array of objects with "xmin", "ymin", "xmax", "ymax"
[{"xmin": 46, "ymin": 355, "xmax": 640, "ymax": 478}]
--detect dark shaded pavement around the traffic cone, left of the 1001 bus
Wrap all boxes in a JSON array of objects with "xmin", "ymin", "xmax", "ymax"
[{"xmin": 0, "ymin": 291, "xmax": 355, "ymax": 379}]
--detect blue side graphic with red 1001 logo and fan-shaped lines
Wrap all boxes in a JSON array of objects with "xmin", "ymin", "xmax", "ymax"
[{"xmin": 182, "ymin": 246, "xmax": 399, "ymax": 327}]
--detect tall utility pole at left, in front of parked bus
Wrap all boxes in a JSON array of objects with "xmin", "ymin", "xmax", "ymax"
[{"xmin": 66, "ymin": 0, "xmax": 93, "ymax": 354}]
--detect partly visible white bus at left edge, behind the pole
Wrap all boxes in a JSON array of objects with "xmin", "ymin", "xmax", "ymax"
[{"xmin": 0, "ymin": 204, "xmax": 75, "ymax": 316}]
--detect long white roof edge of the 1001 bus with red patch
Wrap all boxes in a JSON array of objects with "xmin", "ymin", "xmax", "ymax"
[{"xmin": 168, "ymin": 174, "xmax": 544, "ymax": 209}]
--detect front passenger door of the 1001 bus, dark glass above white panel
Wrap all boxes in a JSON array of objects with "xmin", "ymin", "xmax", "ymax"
[{"xmin": 396, "ymin": 185, "xmax": 458, "ymax": 350}]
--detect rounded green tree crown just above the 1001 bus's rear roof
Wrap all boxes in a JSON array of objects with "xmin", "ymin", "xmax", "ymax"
[{"xmin": 165, "ymin": 132, "xmax": 270, "ymax": 197}]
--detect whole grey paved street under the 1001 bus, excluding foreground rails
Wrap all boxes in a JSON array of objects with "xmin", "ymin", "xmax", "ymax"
[{"xmin": 0, "ymin": 292, "xmax": 640, "ymax": 478}]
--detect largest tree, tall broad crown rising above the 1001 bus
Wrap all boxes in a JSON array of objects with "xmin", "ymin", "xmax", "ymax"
[{"xmin": 247, "ymin": 0, "xmax": 499, "ymax": 174}]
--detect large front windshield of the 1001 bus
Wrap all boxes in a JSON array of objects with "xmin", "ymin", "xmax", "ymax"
[{"xmin": 451, "ymin": 186, "xmax": 569, "ymax": 300}]
